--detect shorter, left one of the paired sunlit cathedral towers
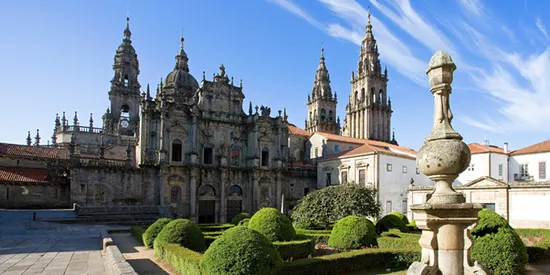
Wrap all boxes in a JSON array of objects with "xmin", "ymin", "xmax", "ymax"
[{"xmin": 305, "ymin": 49, "xmax": 340, "ymax": 135}]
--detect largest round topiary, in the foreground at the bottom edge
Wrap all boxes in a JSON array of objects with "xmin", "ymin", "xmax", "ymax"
[{"xmin": 200, "ymin": 226, "xmax": 282, "ymax": 275}]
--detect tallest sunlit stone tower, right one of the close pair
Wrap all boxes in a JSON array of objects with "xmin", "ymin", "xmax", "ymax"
[{"xmin": 343, "ymin": 14, "xmax": 393, "ymax": 142}]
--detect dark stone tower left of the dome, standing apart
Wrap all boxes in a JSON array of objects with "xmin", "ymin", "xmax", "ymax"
[{"xmin": 103, "ymin": 18, "xmax": 141, "ymax": 136}]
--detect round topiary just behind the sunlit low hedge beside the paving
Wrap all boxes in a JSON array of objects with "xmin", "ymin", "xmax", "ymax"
[{"xmin": 157, "ymin": 219, "xmax": 205, "ymax": 252}]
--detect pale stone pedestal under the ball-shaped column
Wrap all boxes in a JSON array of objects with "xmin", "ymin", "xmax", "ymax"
[{"xmin": 407, "ymin": 203, "xmax": 490, "ymax": 275}]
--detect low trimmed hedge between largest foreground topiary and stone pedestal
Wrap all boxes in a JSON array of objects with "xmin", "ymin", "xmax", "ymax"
[{"xmin": 277, "ymin": 248, "xmax": 421, "ymax": 275}]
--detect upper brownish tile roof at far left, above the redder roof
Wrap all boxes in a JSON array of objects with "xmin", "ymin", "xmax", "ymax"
[{"xmin": 0, "ymin": 143, "xmax": 68, "ymax": 159}]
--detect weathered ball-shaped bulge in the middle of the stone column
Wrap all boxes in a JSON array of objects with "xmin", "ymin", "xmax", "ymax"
[{"xmin": 416, "ymin": 139, "xmax": 471, "ymax": 177}]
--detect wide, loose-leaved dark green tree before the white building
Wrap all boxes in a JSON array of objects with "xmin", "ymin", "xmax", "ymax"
[{"xmin": 292, "ymin": 183, "xmax": 380, "ymax": 231}]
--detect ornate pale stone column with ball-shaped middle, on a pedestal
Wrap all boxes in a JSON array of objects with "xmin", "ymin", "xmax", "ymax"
[{"xmin": 407, "ymin": 51, "xmax": 488, "ymax": 275}]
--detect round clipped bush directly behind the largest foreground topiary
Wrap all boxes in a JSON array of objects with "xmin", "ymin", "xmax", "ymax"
[{"xmin": 248, "ymin": 208, "xmax": 296, "ymax": 242}]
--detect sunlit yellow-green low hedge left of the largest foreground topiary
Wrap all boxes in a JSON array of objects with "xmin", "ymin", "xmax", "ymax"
[{"xmin": 154, "ymin": 240, "xmax": 202, "ymax": 274}]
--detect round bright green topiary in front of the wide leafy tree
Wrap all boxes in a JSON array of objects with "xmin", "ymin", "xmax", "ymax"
[{"xmin": 328, "ymin": 216, "xmax": 376, "ymax": 249}]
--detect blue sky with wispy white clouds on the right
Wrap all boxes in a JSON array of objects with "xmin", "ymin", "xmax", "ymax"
[{"xmin": 0, "ymin": 0, "xmax": 550, "ymax": 150}]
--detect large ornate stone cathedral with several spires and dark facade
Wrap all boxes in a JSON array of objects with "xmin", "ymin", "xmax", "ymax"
[{"xmin": 0, "ymin": 14, "xmax": 406, "ymax": 223}]
